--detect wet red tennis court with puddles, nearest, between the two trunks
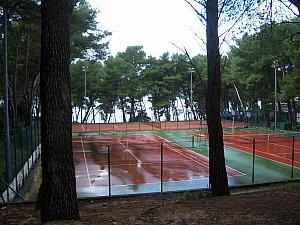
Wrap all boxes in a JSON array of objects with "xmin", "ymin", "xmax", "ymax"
[{"xmin": 73, "ymin": 133, "xmax": 244, "ymax": 197}]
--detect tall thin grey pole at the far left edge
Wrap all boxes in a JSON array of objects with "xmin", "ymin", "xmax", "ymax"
[{"xmin": 2, "ymin": 0, "xmax": 11, "ymax": 183}]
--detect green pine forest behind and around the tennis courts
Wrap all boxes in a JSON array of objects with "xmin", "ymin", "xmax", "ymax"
[{"xmin": 0, "ymin": 0, "xmax": 300, "ymax": 135}]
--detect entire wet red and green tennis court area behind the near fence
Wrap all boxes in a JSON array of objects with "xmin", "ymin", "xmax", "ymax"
[{"xmin": 73, "ymin": 120, "xmax": 300, "ymax": 197}]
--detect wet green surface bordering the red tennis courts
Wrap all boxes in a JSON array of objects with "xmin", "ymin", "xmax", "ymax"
[{"xmin": 73, "ymin": 129, "xmax": 300, "ymax": 196}]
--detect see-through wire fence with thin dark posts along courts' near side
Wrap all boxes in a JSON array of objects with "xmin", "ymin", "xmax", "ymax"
[{"xmin": 74, "ymin": 136, "xmax": 300, "ymax": 196}]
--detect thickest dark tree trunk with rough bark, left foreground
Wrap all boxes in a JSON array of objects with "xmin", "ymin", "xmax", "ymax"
[{"xmin": 39, "ymin": 0, "xmax": 79, "ymax": 222}]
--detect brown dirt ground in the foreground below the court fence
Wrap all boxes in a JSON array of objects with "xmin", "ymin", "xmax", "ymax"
[{"xmin": 0, "ymin": 189, "xmax": 300, "ymax": 225}]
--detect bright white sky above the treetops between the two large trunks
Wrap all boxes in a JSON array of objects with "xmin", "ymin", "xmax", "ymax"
[{"xmin": 90, "ymin": 0, "xmax": 205, "ymax": 57}]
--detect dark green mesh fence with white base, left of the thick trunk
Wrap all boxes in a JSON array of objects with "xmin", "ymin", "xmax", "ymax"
[{"xmin": 0, "ymin": 121, "xmax": 41, "ymax": 202}]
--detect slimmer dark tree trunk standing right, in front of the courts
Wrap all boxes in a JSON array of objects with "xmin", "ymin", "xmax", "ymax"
[{"xmin": 206, "ymin": 0, "xmax": 229, "ymax": 196}]
